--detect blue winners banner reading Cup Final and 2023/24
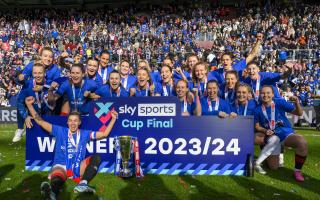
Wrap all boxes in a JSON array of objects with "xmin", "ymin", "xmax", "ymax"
[{"xmin": 26, "ymin": 97, "xmax": 254, "ymax": 175}]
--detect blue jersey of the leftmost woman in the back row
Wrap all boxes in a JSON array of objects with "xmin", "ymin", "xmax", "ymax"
[{"xmin": 22, "ymin": 61, "xmax": 61, "ymax": 85}]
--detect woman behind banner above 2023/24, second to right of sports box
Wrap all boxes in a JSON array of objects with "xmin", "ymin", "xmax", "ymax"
[{"xmin": 200, "ymin": 80, "xmax": 230, "ymax": 118}]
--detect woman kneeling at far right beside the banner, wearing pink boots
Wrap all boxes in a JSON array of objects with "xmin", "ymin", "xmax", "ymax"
[{"xmin": 254, "ymin": 86, "xmax": 308, "ymax": 182}]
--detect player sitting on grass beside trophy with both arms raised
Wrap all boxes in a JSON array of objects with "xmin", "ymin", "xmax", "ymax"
[{"xmin": 25, "ymin": 97, "xmax": 118, "ymax": 199}]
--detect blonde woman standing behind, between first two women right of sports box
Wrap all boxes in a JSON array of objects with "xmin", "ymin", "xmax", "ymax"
[{"xmin": 189, "ymin": 62, "xmax": 208, "ymax": 98}]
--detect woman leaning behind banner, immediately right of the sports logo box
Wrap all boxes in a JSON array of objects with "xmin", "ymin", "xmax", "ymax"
[{"xmin": 175, "ymin": 80, "xmax": 201, "ymax": 116}]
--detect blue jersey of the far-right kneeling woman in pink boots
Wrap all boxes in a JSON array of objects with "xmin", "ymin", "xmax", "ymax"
[{"xmin": 254, "ymin": 99, "xmax": 295, "ymax": 141}]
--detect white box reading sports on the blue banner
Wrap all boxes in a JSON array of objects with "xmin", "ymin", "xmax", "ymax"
[{"xmin": 138, "ymin": 103, "xmax": 176, "ymax": 117}]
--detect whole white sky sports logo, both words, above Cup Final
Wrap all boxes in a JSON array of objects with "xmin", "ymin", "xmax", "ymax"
[{"xmin": 119, "ymin": 103, "xmax": 176, "ymax": 117}]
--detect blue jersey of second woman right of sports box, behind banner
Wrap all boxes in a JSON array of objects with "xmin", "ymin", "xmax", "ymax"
[{"xmin": 200, "ymin": 97, "xmax": 230, "ymax": 115}]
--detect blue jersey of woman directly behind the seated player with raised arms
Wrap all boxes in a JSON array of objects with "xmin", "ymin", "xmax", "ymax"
[{"xmin": 56, "ymin": 79, "xmax": 97, "ymax": 115}]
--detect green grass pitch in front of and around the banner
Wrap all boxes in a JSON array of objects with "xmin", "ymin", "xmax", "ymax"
[{"xmin": 0, "ymin": 125, "xmax": 320, "ymax": 200}]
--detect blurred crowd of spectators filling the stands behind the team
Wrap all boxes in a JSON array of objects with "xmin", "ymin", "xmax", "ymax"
[{"xmin": 0, "ymin": 3, "xmax": 320, "ymax": 106}]
